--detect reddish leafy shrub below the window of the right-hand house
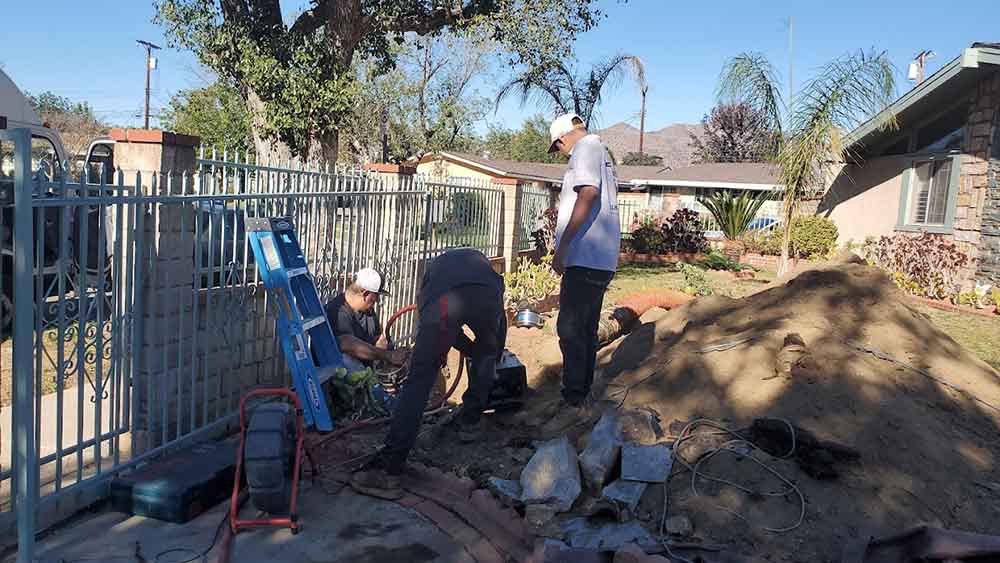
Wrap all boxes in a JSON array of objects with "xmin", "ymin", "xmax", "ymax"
[{"xmin": 862, "ymin": 233, "xmax": 969, "ymax": 299}]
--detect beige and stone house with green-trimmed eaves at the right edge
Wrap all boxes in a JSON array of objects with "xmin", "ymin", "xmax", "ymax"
[{"xmin": 817, "ymin": 43, "xmax": 1000, "ymax": 284}]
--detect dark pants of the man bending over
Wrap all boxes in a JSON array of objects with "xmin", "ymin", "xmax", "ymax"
[{"xmin": 381, "ymin": 285, "xmax": 506, "ymax": 474}]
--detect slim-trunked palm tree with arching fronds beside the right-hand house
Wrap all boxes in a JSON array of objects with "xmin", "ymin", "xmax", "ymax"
[{"xmin": 718, "ymin": 51, "xmax": 896, "ymax": 274}]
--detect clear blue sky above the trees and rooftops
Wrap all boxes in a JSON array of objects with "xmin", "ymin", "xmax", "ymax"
[{"xmin": 0, "ymin": 0, "xmax": 1000, "ymax": 130}]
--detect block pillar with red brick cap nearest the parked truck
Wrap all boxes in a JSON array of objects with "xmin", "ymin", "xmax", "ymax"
[{"xmin": 111, "ymin": 129, "xmax": 200, "ymax": 454}]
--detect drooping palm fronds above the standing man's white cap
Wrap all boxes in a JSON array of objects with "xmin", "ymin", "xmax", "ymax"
[{"xmin": 496, "ymin": 54, "xmax": 646, "ymax": 125}]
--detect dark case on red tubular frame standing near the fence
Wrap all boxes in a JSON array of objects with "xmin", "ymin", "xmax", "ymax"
[{"xmin": 229, "ymin": 387, "xmax": 317, "ymax": 535}]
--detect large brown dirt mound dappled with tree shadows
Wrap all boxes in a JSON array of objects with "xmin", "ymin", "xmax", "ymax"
[{"xmin": 602, "ymin": 260, "xmax": 1000, "ymax": 561}]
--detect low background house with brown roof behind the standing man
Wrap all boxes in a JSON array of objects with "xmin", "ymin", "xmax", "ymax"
[{"xmin": 417, "ymin": 151, "xmax": 780, "ymax": 229}]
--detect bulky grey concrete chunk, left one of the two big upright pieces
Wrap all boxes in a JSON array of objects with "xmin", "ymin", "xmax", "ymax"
[{"xmin": 521, "ymin": 436, "xmax": 583, "ymax": 512}]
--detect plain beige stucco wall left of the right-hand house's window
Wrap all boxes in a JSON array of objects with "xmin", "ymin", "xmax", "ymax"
[{"xmin": 817, "ymin": 156, "xmax": 907, "ymax": 245}]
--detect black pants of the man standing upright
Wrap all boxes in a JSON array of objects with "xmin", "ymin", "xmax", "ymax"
[{"xmin": 556, "ymin": 267, "xmax": 615, "ymax": 405}]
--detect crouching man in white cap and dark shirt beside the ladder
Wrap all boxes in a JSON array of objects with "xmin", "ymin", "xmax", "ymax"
[{"xmin": 326, "ymin": 268, "xmax": 406, "ymax": 372}]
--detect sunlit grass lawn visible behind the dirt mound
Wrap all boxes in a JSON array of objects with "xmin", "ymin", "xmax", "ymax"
[{"xmin": 604, "ymin": 266, "xmax": 1000, "ymax": 370}]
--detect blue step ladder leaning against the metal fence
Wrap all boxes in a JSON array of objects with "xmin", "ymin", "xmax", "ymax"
[{"xmin": 246, "ymin": 217, "xmax": 343, "ymax": 432}]
